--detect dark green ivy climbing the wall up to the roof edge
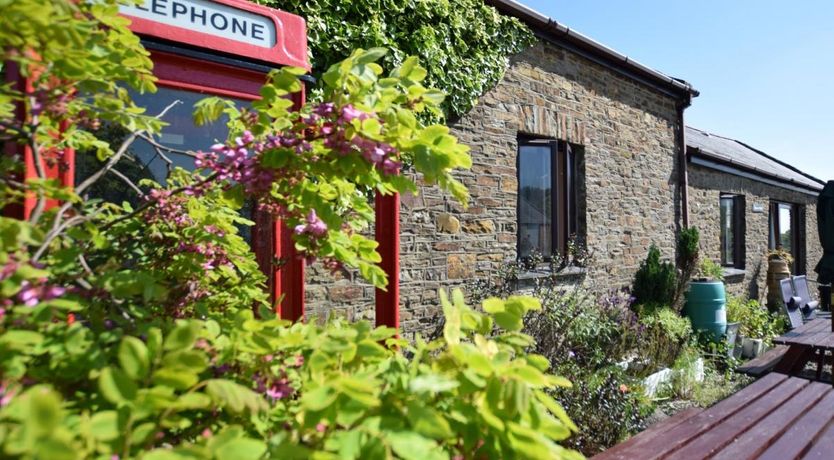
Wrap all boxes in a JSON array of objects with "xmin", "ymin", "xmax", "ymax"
[{"xmin": 257, "ymin": 0, "xmax": 534, "ymax": 119}]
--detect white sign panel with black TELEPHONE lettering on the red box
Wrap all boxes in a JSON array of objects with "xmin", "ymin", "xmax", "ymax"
[{"xmin": 119, "ymin": 0, "xmax": 276, "ymax": 48}]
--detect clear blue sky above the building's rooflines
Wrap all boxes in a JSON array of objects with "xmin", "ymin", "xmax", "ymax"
[{"xmin": 520, "ymin": 0, "xmax": 834, "ymax": 180}]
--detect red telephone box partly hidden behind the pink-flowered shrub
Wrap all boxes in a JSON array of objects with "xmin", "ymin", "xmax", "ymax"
[{"xmin": 8, "ymin": 0, "xmax": 399, "ymax": 327}]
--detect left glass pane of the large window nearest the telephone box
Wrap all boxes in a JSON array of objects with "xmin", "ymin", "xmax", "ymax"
[{"xmin": 518, "ymin": 145, "xmax": 553, "ymax": 257}]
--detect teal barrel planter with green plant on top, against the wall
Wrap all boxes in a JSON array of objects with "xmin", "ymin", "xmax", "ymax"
[{"xmin": 686, "ymin": 259, "xmax": 727, "ymax": 341}]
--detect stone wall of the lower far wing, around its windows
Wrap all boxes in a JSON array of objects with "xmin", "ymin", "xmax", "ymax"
[{"xmin": 688, "ymin": 164, "xmax": 822, "ymax": 302}]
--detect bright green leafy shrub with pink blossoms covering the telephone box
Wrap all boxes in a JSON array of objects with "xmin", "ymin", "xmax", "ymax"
[{"xmin": 0, "ymin": 0, "xmax": 578, "ymax": 459}]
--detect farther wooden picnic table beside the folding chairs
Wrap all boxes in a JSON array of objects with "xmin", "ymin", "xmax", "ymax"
[{"xmin": 773, "ymin": 318, "xmax": 834, "ymax": 380}]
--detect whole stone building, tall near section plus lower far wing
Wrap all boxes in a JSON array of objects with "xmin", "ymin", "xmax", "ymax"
[{"xmin": 307, "ymin": 0, "xmax": 821, "ymax": 335}]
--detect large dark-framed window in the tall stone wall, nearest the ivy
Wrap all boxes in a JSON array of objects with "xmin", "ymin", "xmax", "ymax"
[{"xmin": 517, "ymin": 138, "xmax": 578, "ymax": 259}]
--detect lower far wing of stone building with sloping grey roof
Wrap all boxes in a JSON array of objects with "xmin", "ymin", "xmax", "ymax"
[{"xmin": 686, "ymin": 127, "xmax": 824, "ymax": 299}]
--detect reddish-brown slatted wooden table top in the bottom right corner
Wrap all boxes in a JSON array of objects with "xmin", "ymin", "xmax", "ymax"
[{"xmin": 594, "ymin": 373, "xmax": 834, "ymax": 460}]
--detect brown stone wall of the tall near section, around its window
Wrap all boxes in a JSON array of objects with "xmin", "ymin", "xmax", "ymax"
[{"xmin": 308, "ymin": 42, "xmax": 679, "ymax": 335}]
